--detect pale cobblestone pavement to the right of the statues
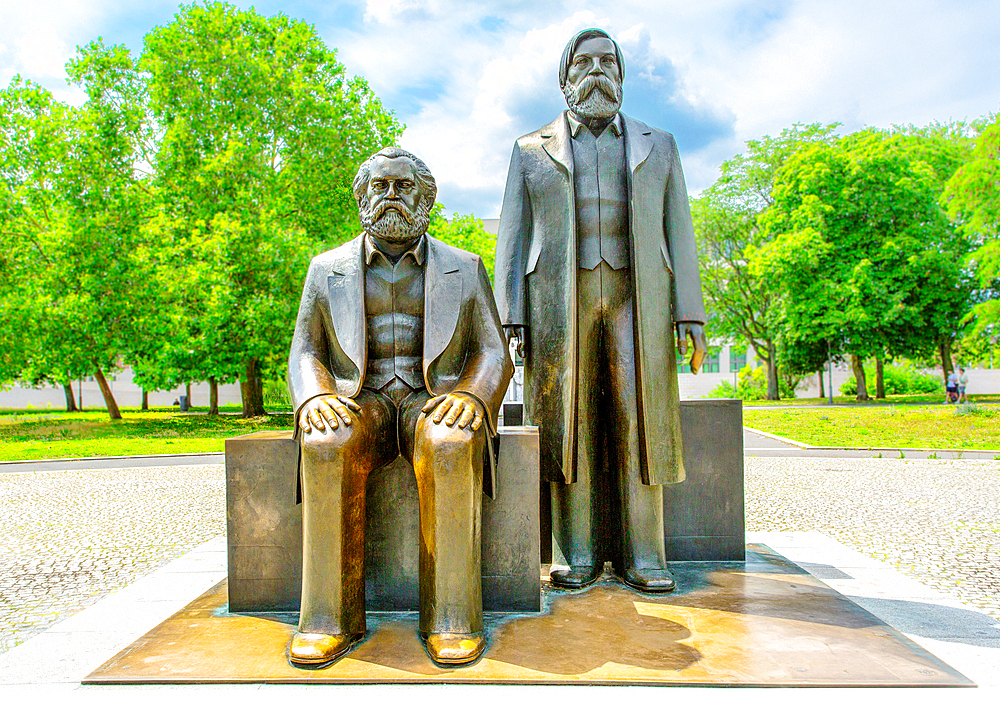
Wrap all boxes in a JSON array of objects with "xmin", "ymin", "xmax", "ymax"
[{"xmin": 745, "ymin": 457, "xmax": 1000, "ymax": 620}]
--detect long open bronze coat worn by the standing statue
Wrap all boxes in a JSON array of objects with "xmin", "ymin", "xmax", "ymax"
[{"xmin": 494, "ymin": 112, "xmax": 705, "ymax": 485}]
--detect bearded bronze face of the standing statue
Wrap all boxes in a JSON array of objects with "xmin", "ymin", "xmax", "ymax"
[{"xmin": 563, "ymin": 37, "xmax": 622, "ymax": 122}]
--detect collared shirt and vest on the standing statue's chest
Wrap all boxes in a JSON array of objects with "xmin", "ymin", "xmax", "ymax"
[{"xmin": 566, "ymin": 112, "xmax": 629, "ymax": 270}]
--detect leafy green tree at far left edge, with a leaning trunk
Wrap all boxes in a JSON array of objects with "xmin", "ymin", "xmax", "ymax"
[{"xmin": 0, "ymin": 69, "xmax": 156, "ymax": 419}]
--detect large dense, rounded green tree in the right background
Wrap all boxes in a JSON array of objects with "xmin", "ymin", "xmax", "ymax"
[{"xmin": 751, "ymin": 129, "xmax": 970, "ymax": 399}]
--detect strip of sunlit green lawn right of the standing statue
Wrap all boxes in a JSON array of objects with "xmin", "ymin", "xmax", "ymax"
[{"xmin": 743, "ymin": 405, "xmax": 1000, "ymax": 450}]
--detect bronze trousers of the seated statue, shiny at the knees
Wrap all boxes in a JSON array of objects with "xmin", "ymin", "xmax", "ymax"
[{"xmin": 299, "ymin": 390, "xmax": 486, "ymax": 635}]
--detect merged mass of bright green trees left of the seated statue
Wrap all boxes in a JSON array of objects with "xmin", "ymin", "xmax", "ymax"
[{"xmin": 0, "ymin": 3, "xmax": 402, "ymax": 416}]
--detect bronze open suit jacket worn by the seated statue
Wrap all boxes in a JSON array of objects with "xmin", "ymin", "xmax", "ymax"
[{"xmin": 288, "ymin": 235, "xmax": 514, "ymax": 496}]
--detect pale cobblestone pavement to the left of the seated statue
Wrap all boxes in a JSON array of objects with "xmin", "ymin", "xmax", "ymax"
[{"xmin": 0, "ymin": 466, "xmax": 226, "ymax": 653}]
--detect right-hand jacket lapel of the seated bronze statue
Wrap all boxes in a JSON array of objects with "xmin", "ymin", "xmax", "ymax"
[{"xmin": 424, "ymin": 236, "xmax": 462, "ymax": 368}]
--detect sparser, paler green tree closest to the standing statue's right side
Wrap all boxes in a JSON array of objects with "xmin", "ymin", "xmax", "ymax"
[{"xmin": 691, "ymin": 124, "xmax": 838, "ymax": 400}]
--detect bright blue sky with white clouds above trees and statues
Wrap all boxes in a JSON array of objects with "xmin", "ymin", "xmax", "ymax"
[{"xmin": 0, "ymin": 0, "xmax": 1000, "ymax": 217}]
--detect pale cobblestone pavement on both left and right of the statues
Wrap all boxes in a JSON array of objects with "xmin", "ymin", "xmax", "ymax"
[{"xmin": 0, "ymin": 458, "xmax": 1000, "ymax": 652}]
